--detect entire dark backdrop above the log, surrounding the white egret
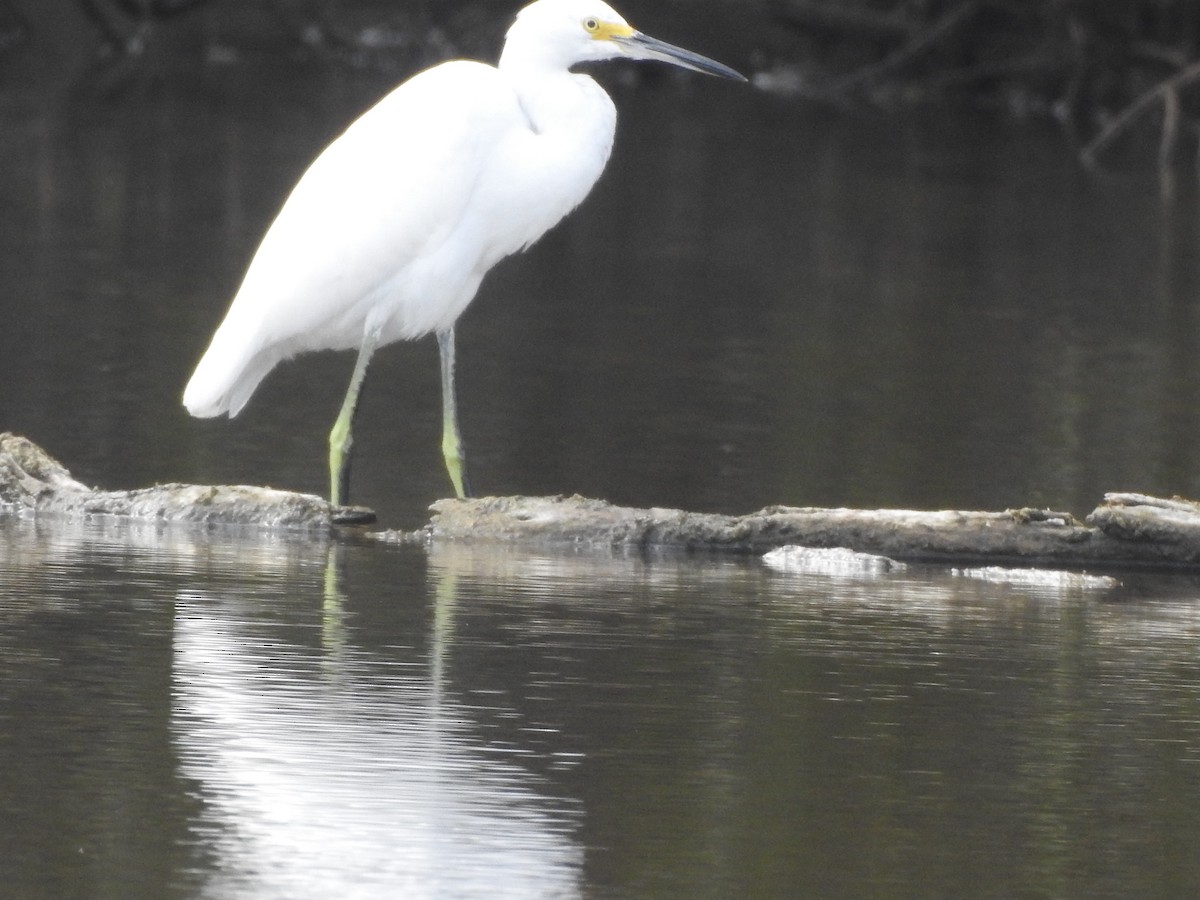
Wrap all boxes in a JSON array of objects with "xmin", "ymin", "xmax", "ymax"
[{"xmin": 0, "ymin": 0, "xmax": 1200, "ymax": 524}]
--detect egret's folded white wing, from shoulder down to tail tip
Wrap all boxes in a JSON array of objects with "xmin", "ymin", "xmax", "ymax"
[{"xmin": 184, "ymin": 61, "xmax": 524, "ymax": 415}]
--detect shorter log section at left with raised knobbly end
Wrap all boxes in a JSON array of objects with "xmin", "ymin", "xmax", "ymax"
[{"xmin": 0, "ymin": 432, "xmax": 371, "ymax": 529}]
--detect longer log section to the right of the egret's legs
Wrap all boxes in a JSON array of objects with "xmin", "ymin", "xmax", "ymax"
[{"xmin": 376, "ymin": 494, "xmax": 1200, "ymax": 568}]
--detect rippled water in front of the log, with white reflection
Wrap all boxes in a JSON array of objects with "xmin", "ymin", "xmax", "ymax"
[{"xmin": 0, "ymin": 522, "xmax": 1200, "ymax": 898}]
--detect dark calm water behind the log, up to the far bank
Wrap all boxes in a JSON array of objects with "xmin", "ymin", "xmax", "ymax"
[{"xmin": 7, "ymin": 52, "xmax": 1200, "ymax": 526}]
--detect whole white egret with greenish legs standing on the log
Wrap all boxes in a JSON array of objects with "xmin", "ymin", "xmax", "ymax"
[{"xmin": 184, "ymin": 0, "xmax": 745, "ymax": 506}]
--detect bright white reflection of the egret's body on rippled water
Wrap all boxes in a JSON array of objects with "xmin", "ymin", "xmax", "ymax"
[{"xmin": 173, "ymin": 596, "xmax": 582, "ymax": 898}]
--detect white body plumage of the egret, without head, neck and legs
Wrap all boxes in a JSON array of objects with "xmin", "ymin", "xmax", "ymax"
[{"xmin": 184, "ymin": 60, "xmax": 617, "ymax": 416}]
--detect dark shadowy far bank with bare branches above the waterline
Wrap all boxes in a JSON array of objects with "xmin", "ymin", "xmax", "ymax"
[{"xmin": 7, "ymin": 0, "xmax": 1200, "ymax": 140}]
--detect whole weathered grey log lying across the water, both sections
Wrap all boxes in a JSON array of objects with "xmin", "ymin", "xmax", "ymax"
[{"xmin": 7, "ymin": 433, "xmax": 1200, "ymax": 569}]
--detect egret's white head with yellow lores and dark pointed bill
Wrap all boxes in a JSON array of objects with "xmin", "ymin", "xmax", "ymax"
[{"xmin": 500, "ymin": 0, "xmax": 745, "ymax": 82}]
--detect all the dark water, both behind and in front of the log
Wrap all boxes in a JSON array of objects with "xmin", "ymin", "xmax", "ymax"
[{"xmin": 7, "ymin": 33, "xmax": 1200, "ymax": 898}]
